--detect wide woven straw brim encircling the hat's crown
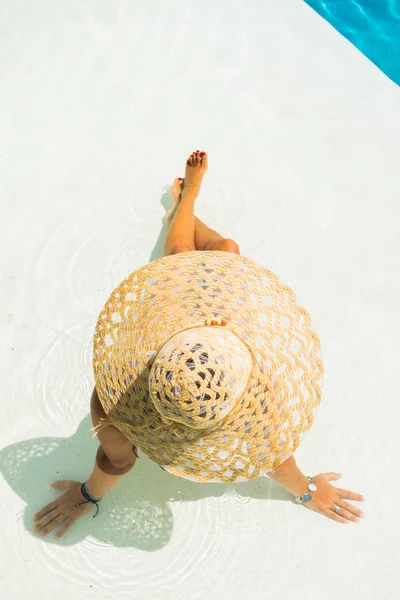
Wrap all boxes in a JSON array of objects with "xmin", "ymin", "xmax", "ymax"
[{"xmin": 93, "ymin": 251, "xmax": 323, "ymax": 481}]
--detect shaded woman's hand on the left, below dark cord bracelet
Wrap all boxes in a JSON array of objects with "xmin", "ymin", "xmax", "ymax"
[{"xmin": 33, "ymin": 480, "xmax": 95, "ymax": 538}]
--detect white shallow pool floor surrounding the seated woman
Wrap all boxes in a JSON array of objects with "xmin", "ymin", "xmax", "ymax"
[{"xmin": 0, "ymin": 0, "xmax": 400, "ymax": 600}]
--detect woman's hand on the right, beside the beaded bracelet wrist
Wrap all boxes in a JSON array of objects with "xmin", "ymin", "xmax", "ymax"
[{"xmin": 304, "ymin": 473, "xmax": 364, "ymax": 525}]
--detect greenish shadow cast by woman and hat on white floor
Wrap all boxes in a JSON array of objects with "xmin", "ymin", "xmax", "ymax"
[{"xmin": 0, "ymin": 415, "xmax": 293, "ymax": 552}]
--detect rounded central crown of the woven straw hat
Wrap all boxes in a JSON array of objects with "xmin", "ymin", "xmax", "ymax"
[{"xmin": 149, "ymin": 327, "xmax": 252, "ymax": 429}]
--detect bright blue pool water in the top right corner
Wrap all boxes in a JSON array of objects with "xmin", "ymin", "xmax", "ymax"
[{"xmin": 305, "ymin": 0, "xmax": 400, "ymax": 85}]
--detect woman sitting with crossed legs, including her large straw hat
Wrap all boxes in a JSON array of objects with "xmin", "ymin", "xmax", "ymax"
[{"xmin": 34, "ymin": 150, "xmax": 364, "ymax": 538}]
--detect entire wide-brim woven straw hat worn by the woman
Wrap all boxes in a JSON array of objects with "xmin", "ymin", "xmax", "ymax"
[{"xmin": 93, "ymin": 251, "xmax": 323, "ymax": 481}]
